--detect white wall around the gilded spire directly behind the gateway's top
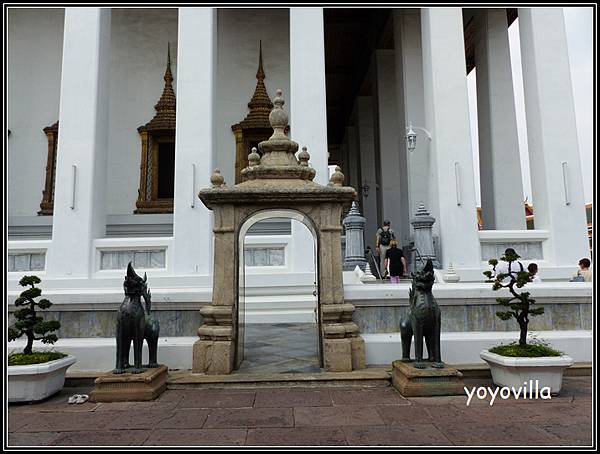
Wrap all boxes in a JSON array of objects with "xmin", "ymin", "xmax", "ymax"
[{"xmin": 215, "ymin": 8, "xmax": 290, "ymax": 184}]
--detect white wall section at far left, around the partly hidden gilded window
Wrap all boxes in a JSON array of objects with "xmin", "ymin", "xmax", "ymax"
[{"xmin": 7, "ymin": 8, "xmax": 64, "ymax": 216}]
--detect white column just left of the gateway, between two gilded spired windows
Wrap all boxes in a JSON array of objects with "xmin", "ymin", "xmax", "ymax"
[{"xmin": 173, "ymin": 8, "xmax": 217, "ymax": 275}]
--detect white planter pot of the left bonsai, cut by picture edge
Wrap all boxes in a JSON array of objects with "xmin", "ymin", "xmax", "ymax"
[{"xmin": 8, "ymin": 355, "xmax": 77, "ymax": 402}]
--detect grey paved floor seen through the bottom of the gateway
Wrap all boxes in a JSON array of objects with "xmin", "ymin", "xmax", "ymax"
[{"xmin": 239, "ymin": 323, "xmax": 321, "ymax": 374}]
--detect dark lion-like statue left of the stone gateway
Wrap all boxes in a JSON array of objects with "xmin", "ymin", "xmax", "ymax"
[{"xmin": 114, "ymin": 262, "xmax": 150, "ymax": 374}]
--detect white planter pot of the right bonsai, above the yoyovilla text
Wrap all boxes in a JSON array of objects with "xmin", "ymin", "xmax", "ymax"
[{"xmin": 480, "ymin": 350, "xmax": 573, "ymax": 394}]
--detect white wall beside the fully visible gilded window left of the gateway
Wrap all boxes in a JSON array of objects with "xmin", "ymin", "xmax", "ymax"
[{"xmin": 106, "ymin": 8, "xmax": 177, "ymax": 215}]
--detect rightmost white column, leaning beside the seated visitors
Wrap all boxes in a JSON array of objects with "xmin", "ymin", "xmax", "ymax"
[{"xmin": 519, "ymin": 8, "xmax": 590, "ymax": 269}]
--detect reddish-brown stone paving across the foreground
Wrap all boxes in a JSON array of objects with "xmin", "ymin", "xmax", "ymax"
[{"xmin": 8, "ymin": 377, "xmax": 592, "ymax": 447}]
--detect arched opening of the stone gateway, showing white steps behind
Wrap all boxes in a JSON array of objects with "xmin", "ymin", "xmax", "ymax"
[{"xmin": 235, "ymin": 210, "xmax": 322, "ymax": 374}]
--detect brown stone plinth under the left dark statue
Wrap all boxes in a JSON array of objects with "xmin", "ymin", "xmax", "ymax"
[{"xmin": 90, "ymin": 365, "xmax": 168, "ymax": 402}]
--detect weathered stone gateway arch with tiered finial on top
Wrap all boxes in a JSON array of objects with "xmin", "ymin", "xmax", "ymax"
[{"xmin": 193, "ymin": 90, "xmax": 365, "ymax": 374}]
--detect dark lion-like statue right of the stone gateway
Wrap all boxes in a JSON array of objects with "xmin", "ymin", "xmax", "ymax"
[{"xmin": 400, "ymin": 259, "xmax": 444, "ymax": 369}]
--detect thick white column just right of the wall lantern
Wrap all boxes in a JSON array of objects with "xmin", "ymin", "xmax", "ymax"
[{"xmin": 421, "ymin": 8, "xmax": 481, "ymax": 269}]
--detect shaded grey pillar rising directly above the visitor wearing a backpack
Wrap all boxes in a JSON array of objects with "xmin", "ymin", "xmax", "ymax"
[{"xmin": 375, "ymin": 50, "xmax": 409, "ymax": 241}]
